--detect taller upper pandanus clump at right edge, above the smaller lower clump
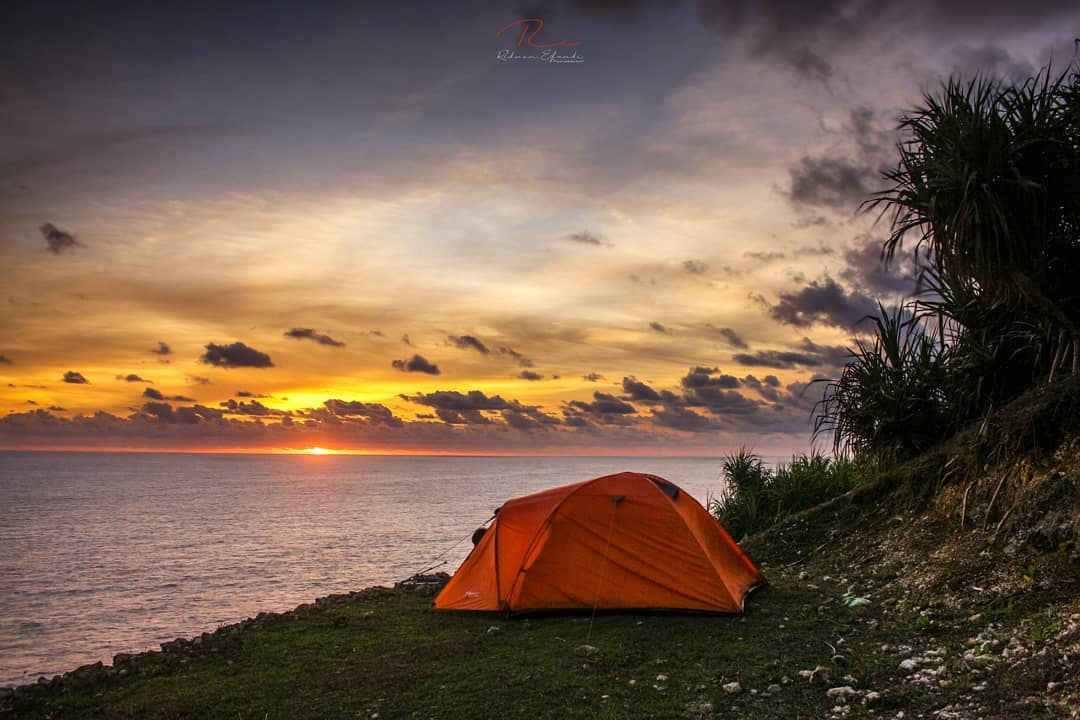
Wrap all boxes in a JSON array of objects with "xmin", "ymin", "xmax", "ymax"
[{"xmin": 867, "ymin": 68, "xmax": 1080, "ymax": 388}]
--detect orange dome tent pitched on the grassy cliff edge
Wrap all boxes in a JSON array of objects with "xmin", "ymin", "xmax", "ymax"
[{"xmin": 435, "ymin": 473, "xmax": 762, "ymax": 612}]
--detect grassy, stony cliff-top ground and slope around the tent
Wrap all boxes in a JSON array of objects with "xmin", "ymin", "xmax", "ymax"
[{"xmin": 0, "ymin": 381, "xmax": 1080, "ymax": 720}]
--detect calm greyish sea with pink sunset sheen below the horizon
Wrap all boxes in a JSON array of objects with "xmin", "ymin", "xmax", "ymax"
[{"xmin": 0, "ymin": 452, "xmax": 768, "ymax": 685}]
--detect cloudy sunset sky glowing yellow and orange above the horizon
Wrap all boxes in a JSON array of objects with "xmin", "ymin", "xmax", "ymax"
[{"xmin": 0, "ymin": 0, "xmax": 1080, "ymax": 456}]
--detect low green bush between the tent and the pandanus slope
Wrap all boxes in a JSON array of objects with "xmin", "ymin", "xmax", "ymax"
[{"xmin": 708, "ymin": 448, "xmax": 865, "ymax": 538}]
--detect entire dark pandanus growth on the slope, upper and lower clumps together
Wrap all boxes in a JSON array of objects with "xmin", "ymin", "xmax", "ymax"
[{"xmin": 814, "ymin": 67, "xmax": 1080, "ymax": 461}]
